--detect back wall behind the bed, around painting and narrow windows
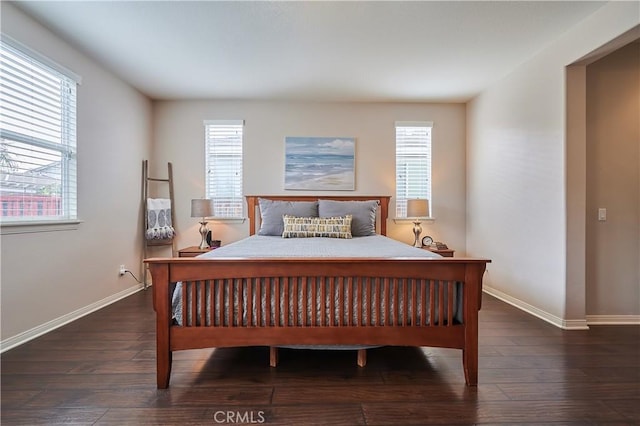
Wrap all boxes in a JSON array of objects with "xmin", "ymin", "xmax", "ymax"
[{"xmin": 153, "ymin": 101, "xmax": 466, "ymax": 250}]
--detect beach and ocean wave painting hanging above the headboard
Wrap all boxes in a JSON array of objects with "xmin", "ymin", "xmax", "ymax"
[{"xmin": 284, "ymin": 136, "xmax": 356, "ymax": 191}]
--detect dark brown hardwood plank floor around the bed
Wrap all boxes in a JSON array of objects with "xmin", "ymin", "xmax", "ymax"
[{"xmin": 1, "ymin": 290, "xmax": 640, "ymax": 425}]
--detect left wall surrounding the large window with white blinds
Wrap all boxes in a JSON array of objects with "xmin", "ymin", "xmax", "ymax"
[{"xmin": 0, "ymin": 2, "xmax": 152, "ymax": 350}]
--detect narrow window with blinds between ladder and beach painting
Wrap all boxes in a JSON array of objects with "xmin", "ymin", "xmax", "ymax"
[{"xmin": 204, "ymin": 120, "xmax": 244, "ymax": 218}]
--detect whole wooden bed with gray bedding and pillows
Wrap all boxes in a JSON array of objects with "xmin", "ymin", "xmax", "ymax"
[{"xmin": 145, "ymin": 196, "xmax": 490, "ymax": 389}]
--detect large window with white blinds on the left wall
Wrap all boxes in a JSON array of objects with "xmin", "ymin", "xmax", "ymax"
[{"xmin": 0, "ymin": 35, "xmax": 79, "ymax": 223}]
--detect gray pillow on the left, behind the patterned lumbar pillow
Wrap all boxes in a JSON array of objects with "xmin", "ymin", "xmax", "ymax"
[{"xmin": 258, "ymin": 198, "xmax": 318, "ymax": 237}]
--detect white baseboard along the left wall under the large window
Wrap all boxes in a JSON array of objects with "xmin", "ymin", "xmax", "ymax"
[{"xmin": 0, "ymin": 285, "xmax": 143, "ymax": 353}]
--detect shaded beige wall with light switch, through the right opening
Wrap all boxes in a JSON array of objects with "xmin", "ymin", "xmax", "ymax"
[{"xmin": 586, "ymin": 42, "xmax": 640, "ymax": 317}]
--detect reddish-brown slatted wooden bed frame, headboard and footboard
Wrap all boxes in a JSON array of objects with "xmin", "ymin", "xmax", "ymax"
[{"xmin": 145, "ymin": 196, "xmax": 490, "ymax": 389}]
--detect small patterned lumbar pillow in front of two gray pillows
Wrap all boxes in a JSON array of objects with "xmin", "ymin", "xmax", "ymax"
[{"xmin": 282, "ymin": 214, "xmax": 352, "ymax": 238}]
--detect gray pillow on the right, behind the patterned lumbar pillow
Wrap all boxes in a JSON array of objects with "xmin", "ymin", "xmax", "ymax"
[{"xmin": 318, "ymin": 200, "xmax": 378, "ymax": 237}]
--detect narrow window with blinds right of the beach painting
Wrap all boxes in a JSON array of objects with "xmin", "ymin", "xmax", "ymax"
[{"xmin": 396, "ymin": 121, "xmax": 433, "ymax": 218}]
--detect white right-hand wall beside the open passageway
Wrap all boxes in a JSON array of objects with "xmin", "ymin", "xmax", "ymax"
[{"xmin": 467, "ymin": 2, "xmax": 640, "ymax": 326}]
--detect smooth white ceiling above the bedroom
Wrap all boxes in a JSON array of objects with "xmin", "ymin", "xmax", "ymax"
[{"xmin": 14, "ymin": 1, "xmax": 606, "ymax": 102}]
